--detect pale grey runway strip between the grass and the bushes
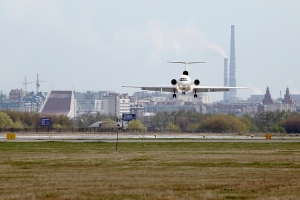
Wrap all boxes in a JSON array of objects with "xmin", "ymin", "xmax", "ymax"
[{"xmin": 0, "ymin": 132, "xmax": 300, "ymax": 143}]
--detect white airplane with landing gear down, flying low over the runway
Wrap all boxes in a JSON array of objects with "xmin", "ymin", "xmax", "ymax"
[{"xmin": 122, "ymin": 61, "xmax": 247, "ymax": 98}]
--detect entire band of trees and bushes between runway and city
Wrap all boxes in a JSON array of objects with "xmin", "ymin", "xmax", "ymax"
[{"xmin": 0, "ymin": 110, "xmax": 300, "ymax": 133}]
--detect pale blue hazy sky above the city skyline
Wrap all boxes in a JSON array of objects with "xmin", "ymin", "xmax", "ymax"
[{"xmin": 0, "ymin": 0, "xmax": 300, "ymax": 101}]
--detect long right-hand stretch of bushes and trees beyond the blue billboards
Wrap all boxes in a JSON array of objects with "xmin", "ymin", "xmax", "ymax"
[{"xmin": 145, "ymin": 110, "xmax": 300, "ymax": 133}]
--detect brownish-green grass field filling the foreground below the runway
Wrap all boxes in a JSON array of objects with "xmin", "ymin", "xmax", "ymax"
[{"xmin": 0, "ymin": 142, "xmax": 300, "ymax": 200}]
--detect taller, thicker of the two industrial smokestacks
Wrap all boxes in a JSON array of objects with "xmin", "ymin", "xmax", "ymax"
[{"xmin": 229, "ymin": 25, "xmax": 236, "ymax": 100}]
